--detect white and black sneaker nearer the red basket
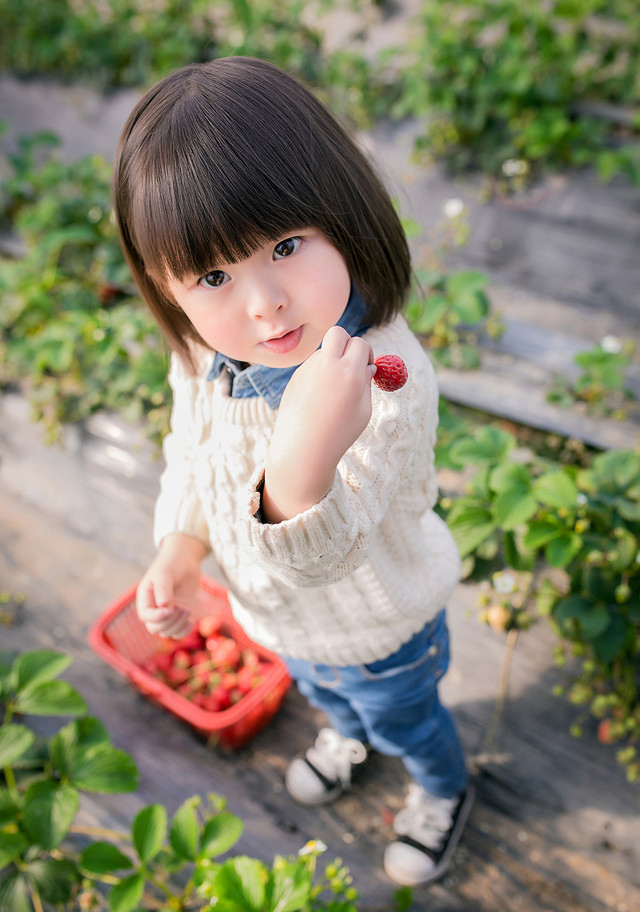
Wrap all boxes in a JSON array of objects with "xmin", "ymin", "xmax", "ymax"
[{"xmin": 285, "ymin": 728, "xmax": 369, "ymax": 805}]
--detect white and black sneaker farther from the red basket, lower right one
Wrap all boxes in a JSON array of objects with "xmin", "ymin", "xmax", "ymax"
[{"xmin": 384, "ymin": 783, "xmax": 474, "ymax": 887}]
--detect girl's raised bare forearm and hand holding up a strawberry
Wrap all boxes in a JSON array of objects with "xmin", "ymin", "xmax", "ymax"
[{"xmin": 262, "ymin": 326, "xmax": 375, "ymax": 522}]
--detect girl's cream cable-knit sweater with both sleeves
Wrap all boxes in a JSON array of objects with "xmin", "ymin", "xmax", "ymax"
[{"xmin": 155, "ymin": 317, "xmax": 460, "ymax": 665}]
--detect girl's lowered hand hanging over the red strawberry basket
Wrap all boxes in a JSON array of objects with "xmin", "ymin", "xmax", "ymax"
[{"xmin": 136, "ymin": 534, "xmax": 207, "ymax": 639}]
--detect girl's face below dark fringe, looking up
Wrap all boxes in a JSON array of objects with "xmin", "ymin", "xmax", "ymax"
[{"xmin": 168, "ymin": 228, "xmax": 351, "ymax": 367}]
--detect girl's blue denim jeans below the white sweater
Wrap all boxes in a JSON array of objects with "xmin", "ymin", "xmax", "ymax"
[{"xmin": 286, "ymin": 611, "xmax": 467, "ymax": 798}]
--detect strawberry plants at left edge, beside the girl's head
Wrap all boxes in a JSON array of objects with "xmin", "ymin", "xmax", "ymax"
[{"xmin": 0, "ymin": 137, "xmax": 170, "ymax": 440}]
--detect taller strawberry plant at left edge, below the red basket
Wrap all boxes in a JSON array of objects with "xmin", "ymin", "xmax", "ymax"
[{"xmin": 0, "ymin": 650, "xmax": 138, "ymax": 912}]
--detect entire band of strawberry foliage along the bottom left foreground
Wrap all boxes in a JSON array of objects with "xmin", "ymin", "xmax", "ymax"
[{"xmin": 0, "ymin": 650, "xmax": 378, "ymax": 912}]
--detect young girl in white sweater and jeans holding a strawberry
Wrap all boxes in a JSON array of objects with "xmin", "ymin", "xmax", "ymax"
[{"xmin": 114, "ymin": 57, "xmax": 471, "ymax": 885}]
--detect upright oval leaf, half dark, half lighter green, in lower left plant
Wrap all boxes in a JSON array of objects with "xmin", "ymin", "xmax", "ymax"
[{"xmin": 24, "ymin": 781, "xmax": 80, "ymax": 849}]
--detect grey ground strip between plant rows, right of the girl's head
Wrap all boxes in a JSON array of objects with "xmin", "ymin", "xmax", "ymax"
[{"xmin": 366, "ymin": 123, "xmax": 640, "ymax": 449}]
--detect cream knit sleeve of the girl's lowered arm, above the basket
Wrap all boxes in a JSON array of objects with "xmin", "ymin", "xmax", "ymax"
[{"xmin": 153, "ymin": 354, "xmax": 210, "ymax": 548}]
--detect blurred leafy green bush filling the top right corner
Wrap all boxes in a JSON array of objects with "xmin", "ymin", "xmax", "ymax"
[{"xmin": 396, "ymin": 0, "xmax": 640, "ymax": 185}]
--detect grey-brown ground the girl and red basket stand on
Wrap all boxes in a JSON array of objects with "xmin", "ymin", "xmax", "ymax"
[{"xmin": 0, "ymin": 393, "xmax": 640, "ymax": 912}]
